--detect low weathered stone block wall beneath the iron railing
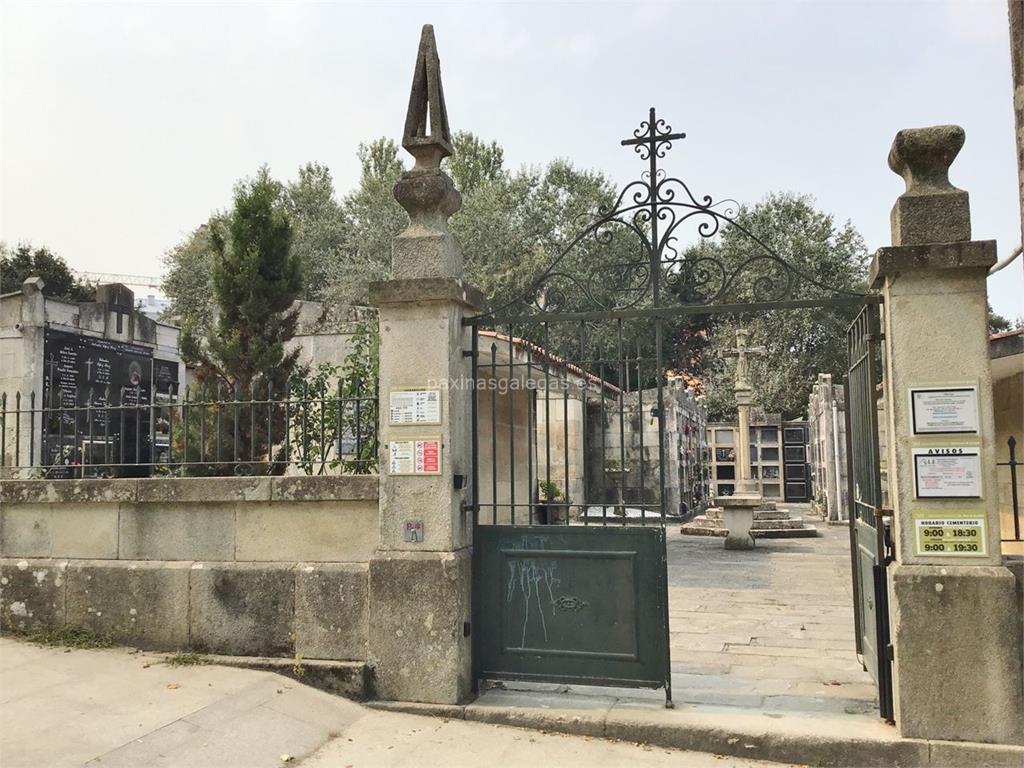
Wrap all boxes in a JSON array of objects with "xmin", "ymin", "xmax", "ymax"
[{"xmin": 0, "ymin": 476, "xmax": 379, "ymax": 660}]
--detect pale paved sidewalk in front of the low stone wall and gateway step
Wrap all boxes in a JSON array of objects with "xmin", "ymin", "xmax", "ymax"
[{"xmin": 0, "ymin": 638, "xmax": 777, "ymax": 768}]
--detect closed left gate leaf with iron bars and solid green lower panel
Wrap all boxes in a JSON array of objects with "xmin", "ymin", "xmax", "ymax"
[{"xmin": 472, "ymin": 316, "xmax": 672, "ymax": 702}]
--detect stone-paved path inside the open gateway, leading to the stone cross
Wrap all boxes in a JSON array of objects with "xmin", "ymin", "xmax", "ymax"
[{"xmin": 669, "ymin": 518, "xmax": 877, "ymax": 720}]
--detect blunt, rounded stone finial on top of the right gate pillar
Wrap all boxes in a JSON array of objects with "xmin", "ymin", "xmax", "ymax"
[{"xmin": 889, "ymin": 125, "xmax": 971, "ymax": 246}]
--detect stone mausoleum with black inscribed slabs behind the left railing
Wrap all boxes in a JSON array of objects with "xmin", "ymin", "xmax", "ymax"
[{"xmin": 0, "ymin": 278, "xmax": 184, "ymax": 477}]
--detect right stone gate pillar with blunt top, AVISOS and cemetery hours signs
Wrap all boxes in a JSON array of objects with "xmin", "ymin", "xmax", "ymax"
[{"xmin": 870, "ymin": 126, "xmax": 1024, "ymax": 742}]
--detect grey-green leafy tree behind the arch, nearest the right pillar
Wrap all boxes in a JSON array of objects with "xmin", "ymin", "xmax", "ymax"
[{"xmin": 688, "ymin": 193, "xmax": 867, "ymax": 420}]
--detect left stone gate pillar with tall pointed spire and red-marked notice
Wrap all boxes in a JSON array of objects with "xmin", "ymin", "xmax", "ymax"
[{"xmin": 370, "ymin": 26, "xmax": 481, "ymax": 703}]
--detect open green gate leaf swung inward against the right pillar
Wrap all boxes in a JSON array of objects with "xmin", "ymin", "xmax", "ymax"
[{"xmin": 846, "ymin": 304, "xmax": 894, "ymax": 721}]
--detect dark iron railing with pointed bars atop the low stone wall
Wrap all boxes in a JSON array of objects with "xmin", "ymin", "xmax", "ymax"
[{"xmin": 0, "ymin": 379, "xmax": 379, "ymax": 479}]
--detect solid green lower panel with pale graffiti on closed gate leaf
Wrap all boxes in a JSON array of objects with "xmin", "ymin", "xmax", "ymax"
[{"xmin": 473, "ymin": 525, "xmax": 669, "ymax": 688}]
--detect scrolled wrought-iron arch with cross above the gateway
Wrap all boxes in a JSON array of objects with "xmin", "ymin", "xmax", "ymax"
[{"xmin": 472, "ymin": 108, "xmax": 869, "ymax": 323}]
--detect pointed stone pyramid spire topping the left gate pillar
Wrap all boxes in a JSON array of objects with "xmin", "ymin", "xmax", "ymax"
[{"xmin": 401, "ymin": 24, "xmax": 453, "ymax": 170}]
